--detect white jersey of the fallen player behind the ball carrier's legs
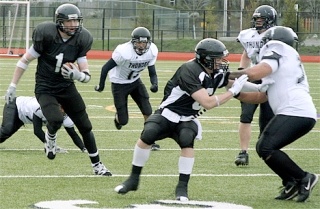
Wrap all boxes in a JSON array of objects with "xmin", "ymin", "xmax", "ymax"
[{"xmin": 16, "ymin": 96, "xmax": 74, "ymax": 128}]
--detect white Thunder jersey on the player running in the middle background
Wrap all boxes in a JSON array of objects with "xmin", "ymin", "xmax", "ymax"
[{"xmin": 109, "ymin": 41, "xmax": 158, "ymax": 84}]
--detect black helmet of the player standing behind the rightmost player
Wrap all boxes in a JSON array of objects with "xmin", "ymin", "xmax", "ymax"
[{"xmin": 252, "ymin": 5, "xmax": 277, "ymax": 31}]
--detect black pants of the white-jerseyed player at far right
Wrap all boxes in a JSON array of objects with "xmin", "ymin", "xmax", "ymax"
[{"xmin": 256, "ymin": 115, "xmax": 316, "ymax": 185}]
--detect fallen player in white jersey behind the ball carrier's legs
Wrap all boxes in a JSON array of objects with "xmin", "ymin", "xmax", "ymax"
[{"xmin": 0, "ymin": 96, "xmax": 86, "ymax": 153}]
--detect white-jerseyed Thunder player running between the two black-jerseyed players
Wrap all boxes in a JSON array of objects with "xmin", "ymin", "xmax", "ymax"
[{"xmin": 95, "ymin": 27, "xmax": 160, "ymax": 150}]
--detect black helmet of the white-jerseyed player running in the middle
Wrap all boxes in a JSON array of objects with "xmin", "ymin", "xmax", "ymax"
[{"xmin": 131, "ymin": 27, "xmax": 151, "ymax": 55}]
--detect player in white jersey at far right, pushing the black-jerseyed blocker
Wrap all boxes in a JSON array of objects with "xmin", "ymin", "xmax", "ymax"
[{"xmin": 230, "ymin": 26, "xmax": 319, "ymax": 202}]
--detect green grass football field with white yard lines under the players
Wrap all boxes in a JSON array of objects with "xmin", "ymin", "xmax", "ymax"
[{"xmin": 0, "ymin": 58, "xmax": 320, "ymax": 209}]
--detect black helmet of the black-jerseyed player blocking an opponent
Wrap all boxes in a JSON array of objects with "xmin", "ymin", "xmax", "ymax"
[{"xmin": 195, "ymin": 38, "xmax": 229, "ymax": 72}]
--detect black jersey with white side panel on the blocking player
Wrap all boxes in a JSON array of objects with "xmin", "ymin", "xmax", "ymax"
[{"xmin": 160, "ymin": 60, "xmax": 222, "ymax": 116}]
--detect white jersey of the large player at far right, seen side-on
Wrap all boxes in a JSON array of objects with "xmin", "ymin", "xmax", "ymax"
[{"xmin": 259, "ymin": 40, "xmax": 317, "ymax": 120}]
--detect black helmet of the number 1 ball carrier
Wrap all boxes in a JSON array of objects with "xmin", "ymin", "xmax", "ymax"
[{"xmin": 55, "ymin": 4, "xmax": 83, "ymax": 36}]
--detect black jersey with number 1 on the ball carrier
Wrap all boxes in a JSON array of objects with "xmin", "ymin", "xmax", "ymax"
[{"xmin": 32, "ymin": 22, "xmax": 93, "ymax": 93}]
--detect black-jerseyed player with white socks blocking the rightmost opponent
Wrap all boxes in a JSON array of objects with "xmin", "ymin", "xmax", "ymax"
[{"xmin": 115, "ymin": 38, "xmax": 247, "ymax": 201}]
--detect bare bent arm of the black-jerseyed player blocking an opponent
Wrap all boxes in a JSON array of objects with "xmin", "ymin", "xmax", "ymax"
[{"xmin": 191, "ymin": 88, "xmax": 233, "ymax": 110}]
